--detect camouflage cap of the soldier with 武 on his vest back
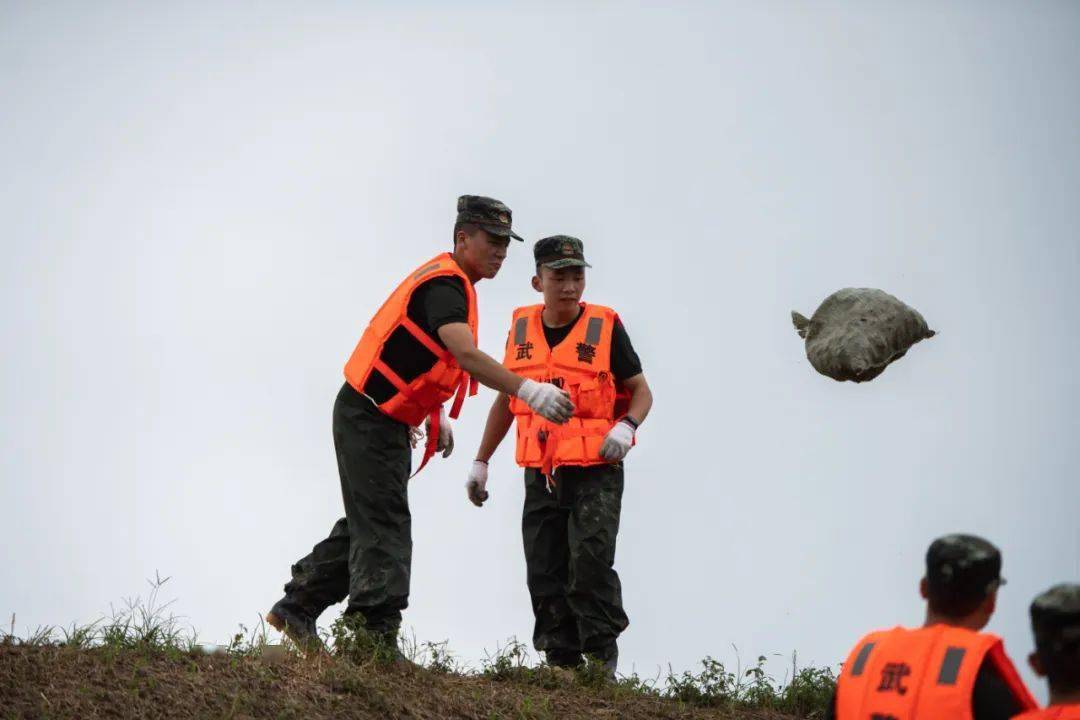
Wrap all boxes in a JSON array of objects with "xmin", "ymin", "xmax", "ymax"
[{"xmin": 927, "ymin": 534, "xmax": 1005, "ymax": 597}]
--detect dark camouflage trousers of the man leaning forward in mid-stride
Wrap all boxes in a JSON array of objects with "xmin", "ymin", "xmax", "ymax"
[{"xmin": 285, "ymin": 383, "xmax": 413, "ymax": 637}]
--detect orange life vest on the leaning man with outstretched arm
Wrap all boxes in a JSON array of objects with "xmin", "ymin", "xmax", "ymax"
[{"xmin": 345, "ymin": 253, "xmax": 478, "ymax": 472}]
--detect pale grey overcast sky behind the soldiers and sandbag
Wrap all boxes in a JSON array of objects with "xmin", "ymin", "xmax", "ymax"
[{"xmin": 0, "ymin": 0, "xmax": 1080, "ymax": 697}]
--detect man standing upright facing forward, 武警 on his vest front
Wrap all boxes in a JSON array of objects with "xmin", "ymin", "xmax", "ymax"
[{"xmin": 467, "ymin": 235, "xmax": 652, "ymax": 677}]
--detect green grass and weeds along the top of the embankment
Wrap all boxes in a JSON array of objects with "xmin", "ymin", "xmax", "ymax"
[{"xmin": 0, "ymin": 576, "xmax": 836, "ymax": 718}]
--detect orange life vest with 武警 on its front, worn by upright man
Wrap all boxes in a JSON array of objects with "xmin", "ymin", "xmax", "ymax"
[{"xmin": 503, "ymin": 303, "xmax": 627, "ymax": 478}]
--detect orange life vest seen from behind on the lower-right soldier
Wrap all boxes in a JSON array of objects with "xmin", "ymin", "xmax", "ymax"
[{"xmin": 836, "ymin": 625, "xmax": 1038, "ymax": 720}]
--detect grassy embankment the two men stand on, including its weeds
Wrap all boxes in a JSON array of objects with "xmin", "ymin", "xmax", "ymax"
[{"xmin": 0, "ymin": 583, "xmax": 835, "ymax": 720}]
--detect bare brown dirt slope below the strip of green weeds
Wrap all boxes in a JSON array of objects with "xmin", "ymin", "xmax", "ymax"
[{"xmin": 0, "ymin": 646, "xmax": 803, "ymax": 720}]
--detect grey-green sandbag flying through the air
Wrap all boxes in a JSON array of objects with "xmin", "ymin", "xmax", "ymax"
[{"xmin": 792, "ymin": 287, "xmax": 934, "ymax": 382}]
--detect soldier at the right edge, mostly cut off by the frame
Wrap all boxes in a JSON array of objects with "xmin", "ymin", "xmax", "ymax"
[{"xmin": 1017, "ymin": 583, "xmax": 1080, "ymax": 720}]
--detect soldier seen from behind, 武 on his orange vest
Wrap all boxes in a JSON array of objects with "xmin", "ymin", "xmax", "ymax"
[{"xmin": 826, "ymin": 534, "xmax": 1037, "ymax": 720}]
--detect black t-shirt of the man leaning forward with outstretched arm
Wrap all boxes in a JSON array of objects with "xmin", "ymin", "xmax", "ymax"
[{"xmin": 364, "ymin": 276, "xmax": 469, "ymax": 405}]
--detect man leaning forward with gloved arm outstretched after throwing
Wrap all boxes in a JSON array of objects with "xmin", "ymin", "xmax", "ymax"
[{"xmin": 267, "ymin": 195, "xmax": 573, "ymax": 649}]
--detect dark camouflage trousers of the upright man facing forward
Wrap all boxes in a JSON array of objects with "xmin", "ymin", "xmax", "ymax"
[{"xmin": 522, "ymin": 464, "xmax": 630, "ymax": 666}]
